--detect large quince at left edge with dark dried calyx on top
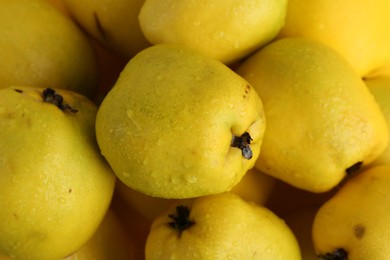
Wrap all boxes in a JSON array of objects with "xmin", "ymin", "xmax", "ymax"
[{"xmin": 0, "ymin": 86, "xmax": 115, "ymax": 260}]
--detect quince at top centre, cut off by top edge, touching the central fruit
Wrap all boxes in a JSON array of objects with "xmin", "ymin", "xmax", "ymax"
[{"xmin": 139, "ymin": 0, "xmax": 287, "ymax": 63}]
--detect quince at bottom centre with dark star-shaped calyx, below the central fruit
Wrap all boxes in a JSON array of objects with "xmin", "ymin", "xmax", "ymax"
[{"xmin": 145, "ymin": 193, "xmax": 301, "ymax": 260}]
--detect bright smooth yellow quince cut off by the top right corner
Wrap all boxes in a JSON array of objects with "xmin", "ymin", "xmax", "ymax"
[{"xmin": 279, "ymin": 0, "xmax": 390, "ymax": 76}]
